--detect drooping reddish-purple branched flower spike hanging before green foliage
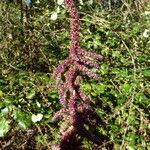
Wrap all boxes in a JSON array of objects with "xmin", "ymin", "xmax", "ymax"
[{"xmin": 53, "ymin": 0, "xmax": 107, "ymax": 150}]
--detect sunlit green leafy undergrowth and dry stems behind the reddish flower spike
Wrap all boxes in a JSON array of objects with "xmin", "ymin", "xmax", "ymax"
[{"xmin": 0, "ymin": 0, "xmax": 150, "ymax": 150}]
